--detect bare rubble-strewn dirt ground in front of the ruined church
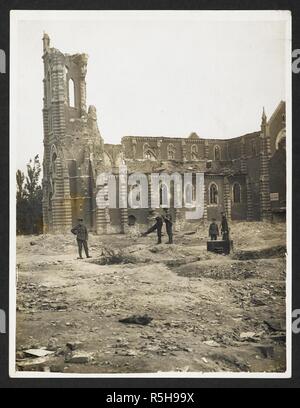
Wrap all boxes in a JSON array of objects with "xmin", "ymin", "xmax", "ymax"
[{"xmin": 16, "ymin": 223, "xmax": 286, "ymax": 373}]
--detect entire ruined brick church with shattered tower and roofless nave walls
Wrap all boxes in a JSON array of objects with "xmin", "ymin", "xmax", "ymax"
[{"xmin": 43, "ymin": 34, "xmax": 286, "ymax": 234}]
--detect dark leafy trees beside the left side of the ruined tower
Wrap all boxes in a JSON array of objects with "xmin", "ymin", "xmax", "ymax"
[{"xmin": 16, "ymin": 155, "xmax": 43, "ymax": 234}]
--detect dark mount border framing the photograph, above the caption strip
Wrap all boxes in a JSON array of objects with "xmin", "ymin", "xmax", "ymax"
[{"xmin": 0, "ymin": 0, "xmax": 300, "ymax": 388}]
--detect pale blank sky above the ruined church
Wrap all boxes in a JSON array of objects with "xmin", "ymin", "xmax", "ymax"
[{"xmin": 11, "ymin": 12, "xmax": 290, "ymax": 169}]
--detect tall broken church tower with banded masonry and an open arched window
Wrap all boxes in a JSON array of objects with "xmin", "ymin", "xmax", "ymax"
[{"xmin": 43, "ymin": 34, "xmax": 103, "ymax": 233}]
